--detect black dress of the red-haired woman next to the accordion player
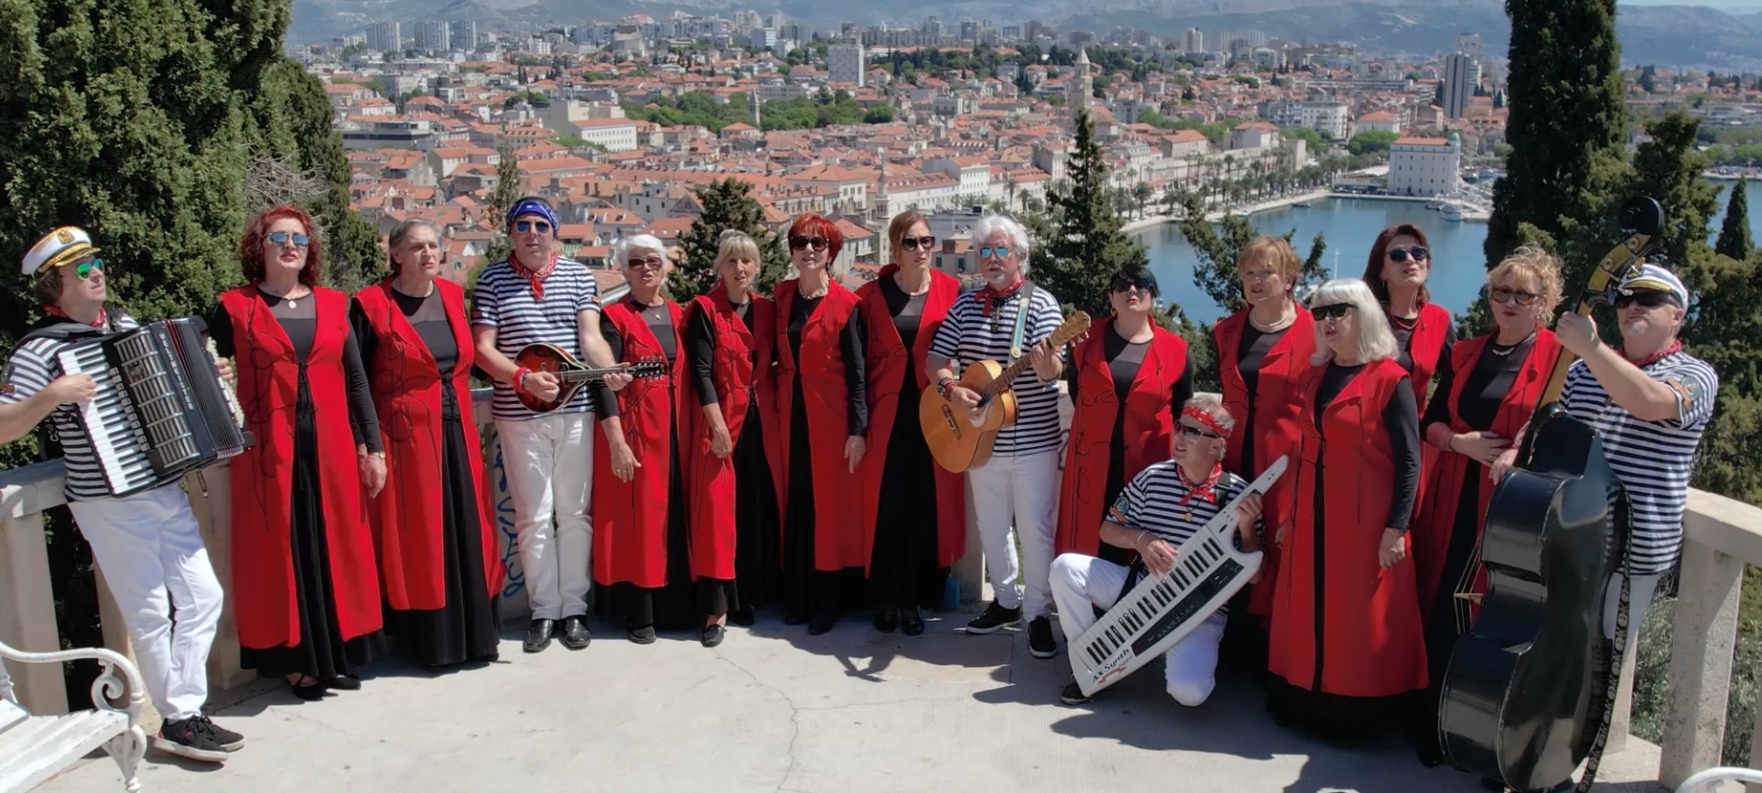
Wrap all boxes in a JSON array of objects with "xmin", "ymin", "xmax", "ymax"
[{"xmin": 208, "ymin": 293, "xmax": 389, "ymax": 680}]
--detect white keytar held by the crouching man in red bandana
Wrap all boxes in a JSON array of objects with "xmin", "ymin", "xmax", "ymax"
[{"xmin": 1070, "ymin": 456, "xmax": 1290, "ymax": 696}]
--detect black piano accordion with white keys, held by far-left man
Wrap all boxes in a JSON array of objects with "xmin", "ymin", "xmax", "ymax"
[{"xmin": 58, "ymin": 317, "xmax": 252, "ymax": 495}]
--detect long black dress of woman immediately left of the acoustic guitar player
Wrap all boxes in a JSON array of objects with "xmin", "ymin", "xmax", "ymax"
[{"xmin": 869, "ymin": 278, "xmax": 948, "ymax": 606}]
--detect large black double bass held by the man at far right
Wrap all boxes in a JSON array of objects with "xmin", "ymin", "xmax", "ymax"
[{"xmin": 1438, "ymin": 197, "xmax": 1663, "ymax": 791}]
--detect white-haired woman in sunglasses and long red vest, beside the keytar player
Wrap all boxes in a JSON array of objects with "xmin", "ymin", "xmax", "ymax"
[{"xmin": 1267, "ymin": 278, "xmax": 1425, "ymax": 738}]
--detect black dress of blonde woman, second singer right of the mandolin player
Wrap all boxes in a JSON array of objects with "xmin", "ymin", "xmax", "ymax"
[{"xmin": 685, "ymin": 300, "xmax": 782, "ymax": 624}]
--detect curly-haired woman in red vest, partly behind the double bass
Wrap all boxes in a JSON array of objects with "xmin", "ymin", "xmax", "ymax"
[{"xmin": 1413, "ymin": 248, "xmax": 1561, "ymax": 765}]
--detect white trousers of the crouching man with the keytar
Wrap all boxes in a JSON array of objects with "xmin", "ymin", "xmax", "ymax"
[{"xmin": 1052, "ymin": 553, "xmax": 1226, "ymax": 708}]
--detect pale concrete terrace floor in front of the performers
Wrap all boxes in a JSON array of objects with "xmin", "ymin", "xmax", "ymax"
[{"xmin": 39, "ymin": 602, "xmax": 1660, "ymax": 793}]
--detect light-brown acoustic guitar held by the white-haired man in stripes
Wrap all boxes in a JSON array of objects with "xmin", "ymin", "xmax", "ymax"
[{"xmin": 918, "ymin": 312, "xmax": 1089, "ymax": 474}]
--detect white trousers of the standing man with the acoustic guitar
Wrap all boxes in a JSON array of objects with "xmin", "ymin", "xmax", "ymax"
[{"xmin": 967, "ymin": 451, "xmax": 1059, "ymax": 619}]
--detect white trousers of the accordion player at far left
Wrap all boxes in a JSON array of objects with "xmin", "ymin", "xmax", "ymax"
[{"xmin": 67, "ymin": 485, "xmax": 226, "ymax": 721}]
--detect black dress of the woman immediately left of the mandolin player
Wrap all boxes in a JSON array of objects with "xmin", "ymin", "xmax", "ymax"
[{"xmin": 351, "ymin": 289, "xmax": 500, "ymax": 666}]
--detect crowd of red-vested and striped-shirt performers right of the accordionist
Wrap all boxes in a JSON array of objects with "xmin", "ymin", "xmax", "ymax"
[{"xmin": 210, "ymin": 199, "xmax": 1716, "ymax": 763}]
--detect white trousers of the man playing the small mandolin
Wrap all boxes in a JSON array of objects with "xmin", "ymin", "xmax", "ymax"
[{"xmin": 495, "ymin": 412, "xmax": 594, "ymax": 620}]
